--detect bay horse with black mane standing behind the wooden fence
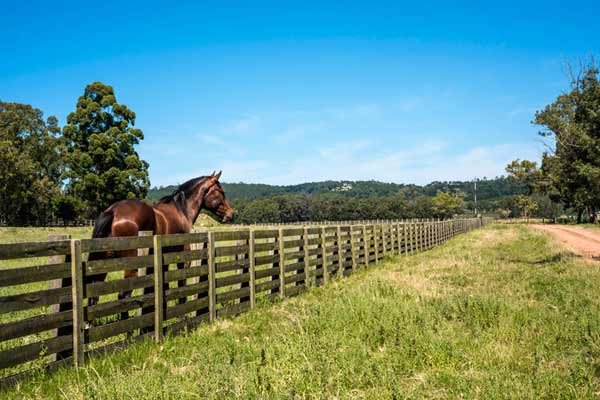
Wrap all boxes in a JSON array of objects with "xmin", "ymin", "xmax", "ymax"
[{"xmin": 86, "ymin": 171, "xmax": 233, "ymax": 318}]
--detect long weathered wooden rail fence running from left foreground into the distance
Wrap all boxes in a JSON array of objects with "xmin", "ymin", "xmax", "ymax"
[{"xmin": 0, "ymin": 218, "xmax": 488, "ymax": 385}]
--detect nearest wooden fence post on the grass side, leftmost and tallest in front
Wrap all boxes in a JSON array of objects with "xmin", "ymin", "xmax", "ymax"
[{"xmin": 71, "ymin": 240, "xmax": 85, "ymax": 368}]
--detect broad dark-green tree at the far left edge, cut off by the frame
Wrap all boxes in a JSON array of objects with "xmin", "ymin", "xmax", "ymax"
[{"xmin": 0, "ymin": 101, "xmax": 62, "ymax": 224}]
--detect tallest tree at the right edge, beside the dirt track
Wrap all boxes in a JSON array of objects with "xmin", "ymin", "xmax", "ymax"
[{"xmin": 534, "ymin": 60, "xmax": 600, "ymax": 222}]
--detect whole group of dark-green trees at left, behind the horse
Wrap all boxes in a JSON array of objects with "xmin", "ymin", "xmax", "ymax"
[{"xmin": 0, "ymin": 82, "xmax": 150, "ymax": 225}]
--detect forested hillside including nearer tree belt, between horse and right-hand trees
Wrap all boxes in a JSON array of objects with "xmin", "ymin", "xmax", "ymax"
[{"xmin": 148, "ymin": 177, "xmax": 527, "ymax": 223}]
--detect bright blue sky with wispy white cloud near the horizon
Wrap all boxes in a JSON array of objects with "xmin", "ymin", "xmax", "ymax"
[{"xmin": 0, "ymin": 0, "xmax": 600, "ymax": 185}]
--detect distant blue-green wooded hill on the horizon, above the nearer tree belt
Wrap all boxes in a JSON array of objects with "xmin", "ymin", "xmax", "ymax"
[{"xmin": 147, "ymin": 177, "xmax": 526, "ymax": 201}]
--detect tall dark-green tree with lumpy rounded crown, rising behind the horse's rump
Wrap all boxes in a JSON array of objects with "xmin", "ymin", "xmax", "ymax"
[{"xmin": 63, "ymin": 82, "xmax": 149, "ymax": 217}]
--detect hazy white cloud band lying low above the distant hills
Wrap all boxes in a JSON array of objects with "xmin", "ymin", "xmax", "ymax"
[{"xmin": 223, "ymin": 141, "xmax": 542, "ymax": 185}]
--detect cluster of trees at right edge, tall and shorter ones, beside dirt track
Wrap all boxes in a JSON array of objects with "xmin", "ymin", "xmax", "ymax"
[{"xmin": 506, "ymin": 59, "xmax": 600, "ymax": 223}]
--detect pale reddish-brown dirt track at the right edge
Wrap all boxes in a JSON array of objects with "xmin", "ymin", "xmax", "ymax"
[{"xmin": 532, "ymin": 225, "xmax": 600, "ymax": 259}]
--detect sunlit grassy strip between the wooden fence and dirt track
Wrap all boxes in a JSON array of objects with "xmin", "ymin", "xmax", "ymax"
[{"xmin": 0, "ymin": 224, "xmax": 600, "ymax": 399}]
